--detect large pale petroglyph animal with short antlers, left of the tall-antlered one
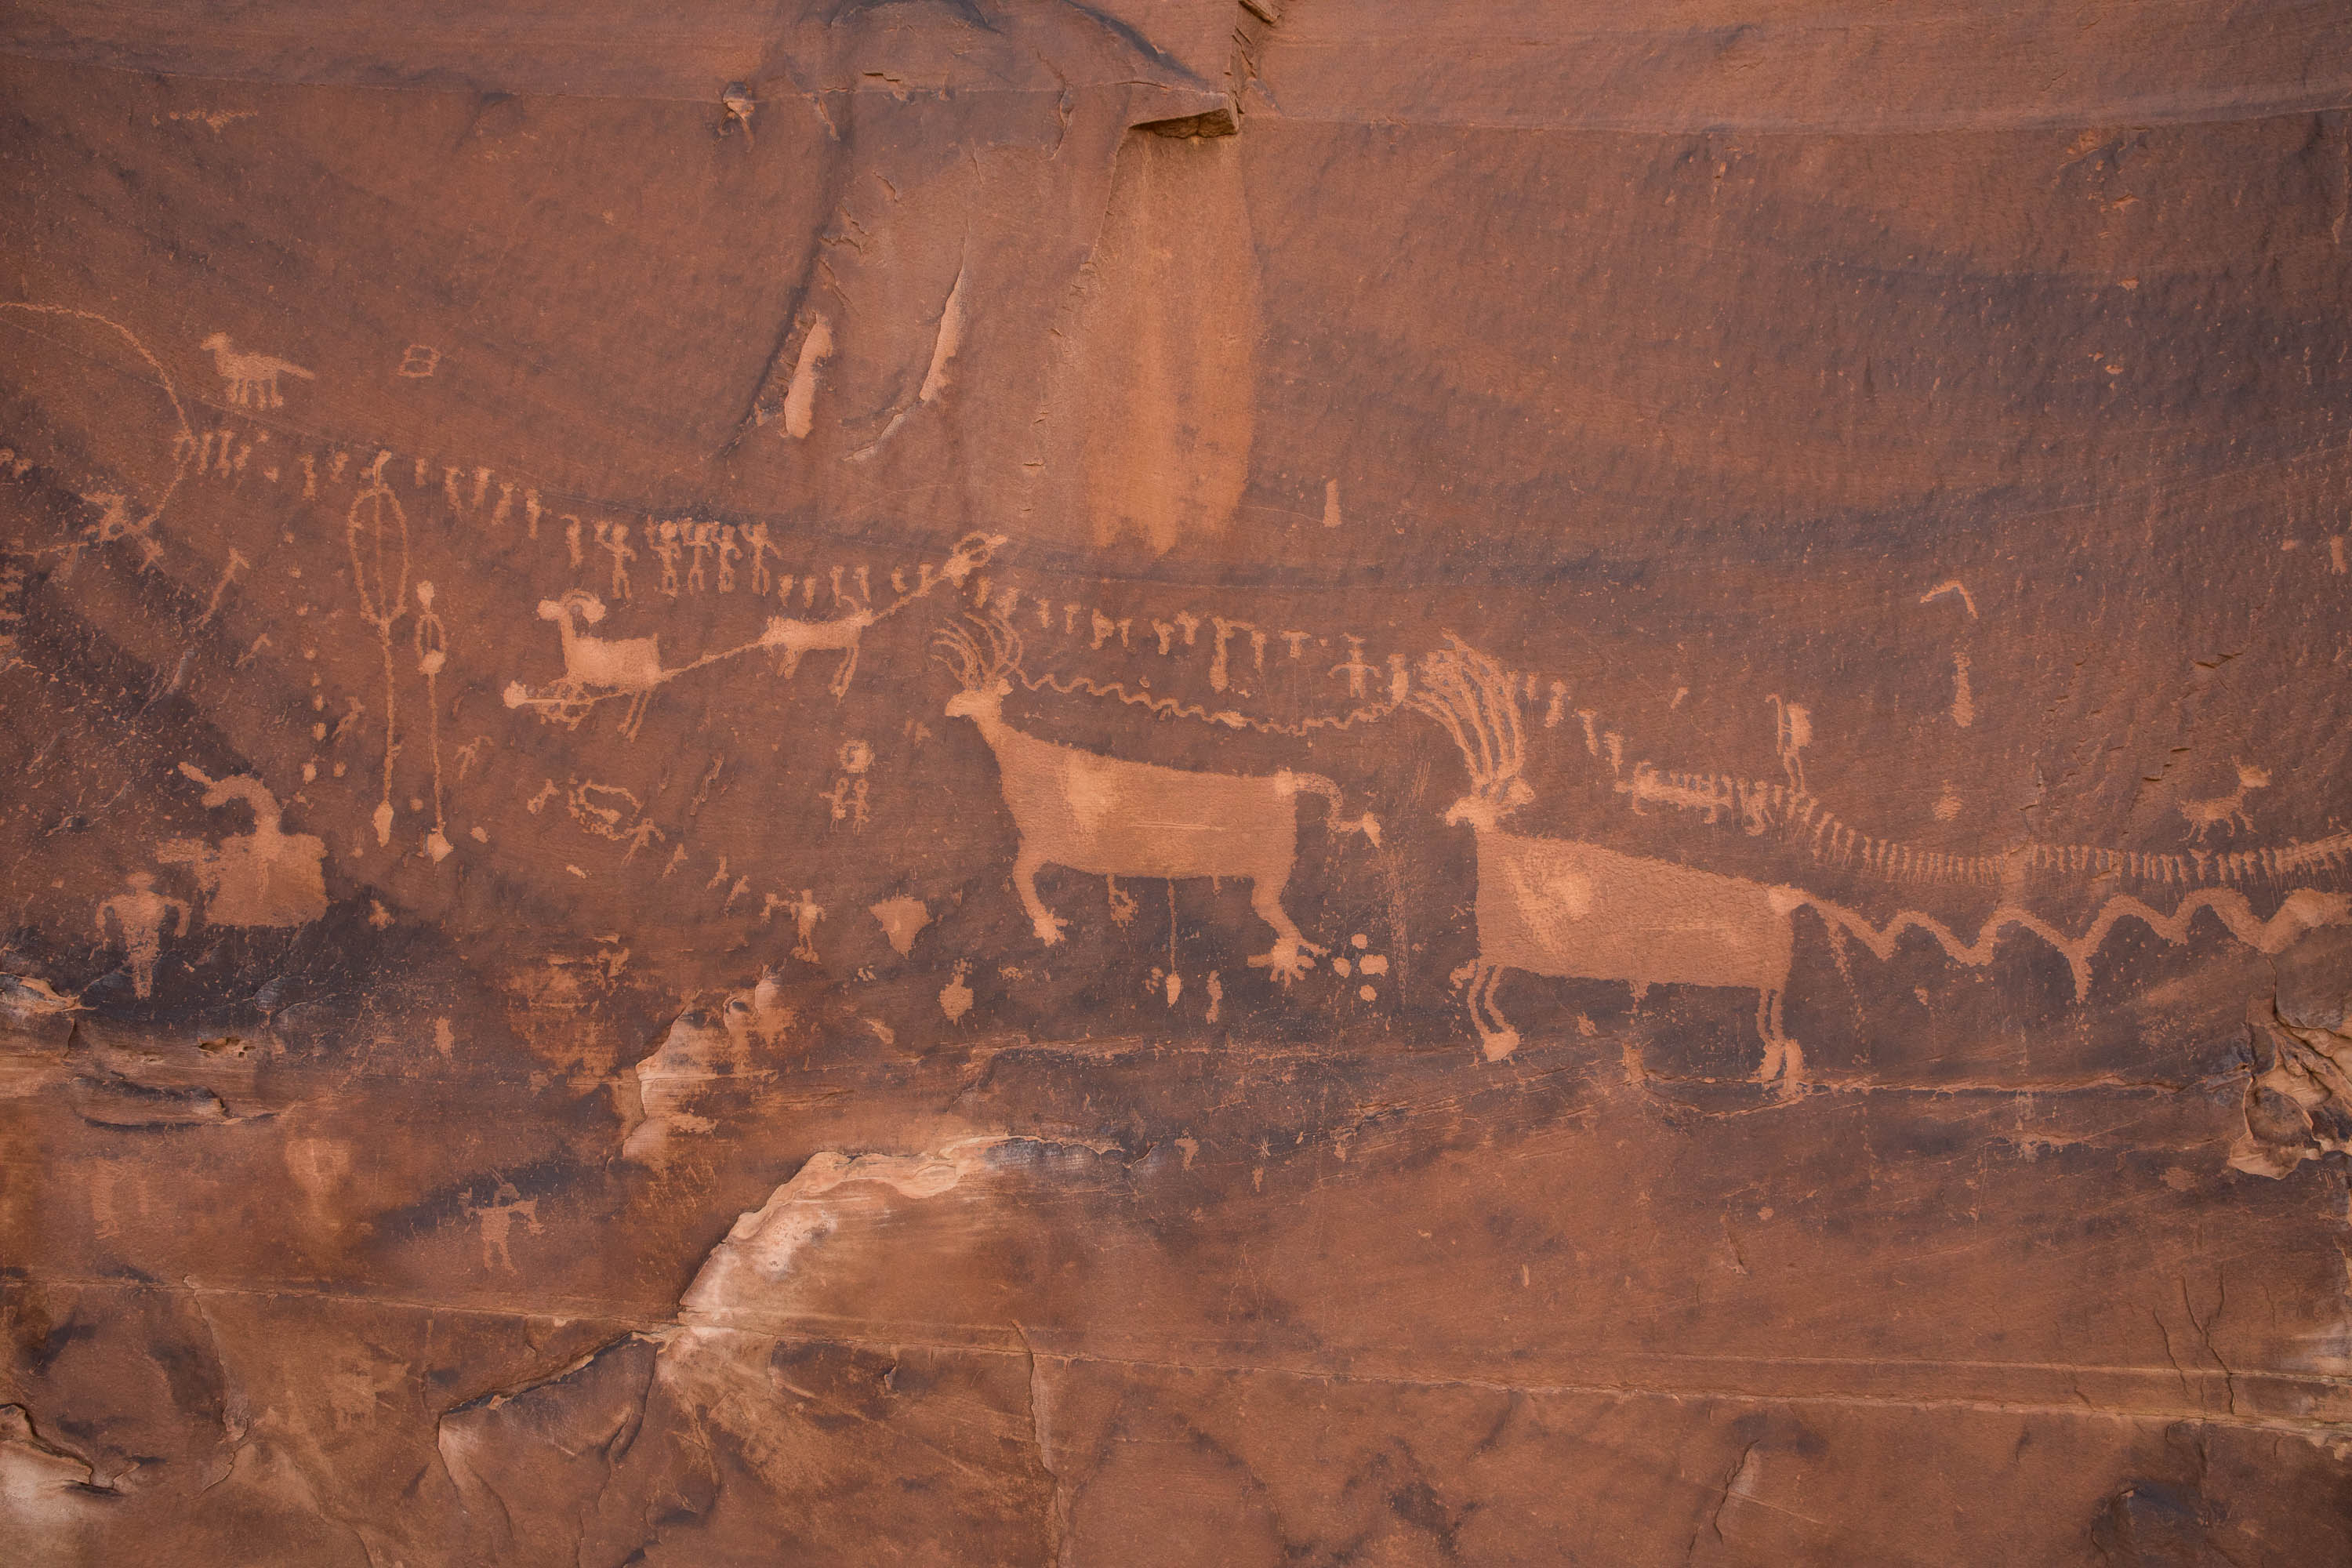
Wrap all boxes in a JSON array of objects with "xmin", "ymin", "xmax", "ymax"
[{"xmin": 934, "ymin": 616, "xmax": 1381, "ymax": 982}]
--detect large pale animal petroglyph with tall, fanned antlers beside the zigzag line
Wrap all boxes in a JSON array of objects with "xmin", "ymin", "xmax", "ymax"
[{"xmin": 1406, "ymin": 635, "xmax": 1806, "ymax": 1093}]
